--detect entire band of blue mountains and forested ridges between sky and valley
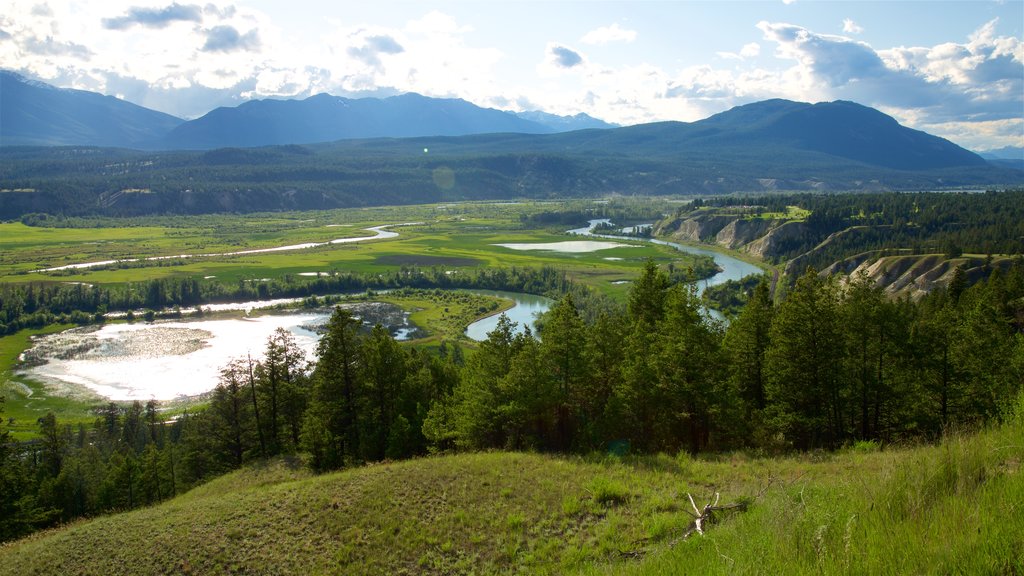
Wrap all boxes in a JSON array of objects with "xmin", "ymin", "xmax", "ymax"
[{"xmin": 0, "ymin": 69, "xmax": 1024, "ymax": 218}]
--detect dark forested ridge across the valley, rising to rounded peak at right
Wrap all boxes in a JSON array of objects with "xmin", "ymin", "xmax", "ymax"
[{"xmin": 0, "ymin": 96, "xmax": 1024, "ymax": 218}]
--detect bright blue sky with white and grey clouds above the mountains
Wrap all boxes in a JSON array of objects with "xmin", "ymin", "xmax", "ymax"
[{"xmin": 0, "ymin": 0, "xmax": 1024, "ymax": 151}]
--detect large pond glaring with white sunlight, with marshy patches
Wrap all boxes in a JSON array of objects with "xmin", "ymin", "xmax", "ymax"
[{"xmin": 20, "ymin": 302, "xmax": 420, "ymax": 402}]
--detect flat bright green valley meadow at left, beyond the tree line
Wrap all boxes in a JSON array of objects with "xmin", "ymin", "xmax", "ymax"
[{"xmin": 0, "ymin": 203, "xmax": 692, "ymax": 294}]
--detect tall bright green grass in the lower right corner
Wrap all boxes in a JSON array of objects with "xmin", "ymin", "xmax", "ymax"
[{"xmin": 593, "ymin": 395, "xmax": 1024, "ymax": 574}]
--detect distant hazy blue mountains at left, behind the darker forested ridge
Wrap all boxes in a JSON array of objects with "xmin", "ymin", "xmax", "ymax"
[{"xmin": 0, "ymin": 71, "xmax": 613, "ymax": 150}]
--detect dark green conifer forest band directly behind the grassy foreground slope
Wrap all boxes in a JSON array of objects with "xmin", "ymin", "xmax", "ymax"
[{"xmin": 0, "ymin": 261, "xmax": 1024, "ymax": 540}]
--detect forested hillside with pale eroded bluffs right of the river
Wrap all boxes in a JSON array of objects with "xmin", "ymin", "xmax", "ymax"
[{"xmin": 654, "ymin": 191, "xmax": 1024, "ymax": 299}]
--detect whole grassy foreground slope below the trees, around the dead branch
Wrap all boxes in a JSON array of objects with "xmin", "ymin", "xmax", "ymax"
[{"xmin": 0, "ymin": 400, "xmax": 1024, "ymax": 574}]
